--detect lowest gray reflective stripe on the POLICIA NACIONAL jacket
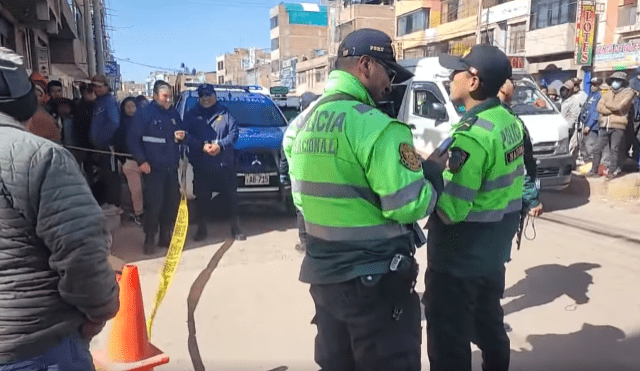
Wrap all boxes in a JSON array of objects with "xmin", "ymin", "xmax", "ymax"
[{"xmin": 305, "ymin": 220, "xmax": 409, "ymax": 241}]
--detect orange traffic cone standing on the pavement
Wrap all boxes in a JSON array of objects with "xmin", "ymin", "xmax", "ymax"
[{"xmin": 93, "ymin": 265, "xmax": 169, "ymax": 371}]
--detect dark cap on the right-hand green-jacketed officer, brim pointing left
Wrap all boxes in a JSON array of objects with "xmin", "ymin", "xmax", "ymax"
[{"xmin": 440, "ymin": 44, "xmax": 512, "ymax": 94}]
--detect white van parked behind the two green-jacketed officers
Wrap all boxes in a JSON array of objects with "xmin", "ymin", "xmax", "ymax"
[{"xmin": 391, "ymin": 57, "xmax": 575, "ymax": 190}]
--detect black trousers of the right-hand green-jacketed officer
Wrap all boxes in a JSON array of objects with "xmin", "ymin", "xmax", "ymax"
[{"xmin": 422, "ymin": 268, "xmax": 510, "ymax": 371}]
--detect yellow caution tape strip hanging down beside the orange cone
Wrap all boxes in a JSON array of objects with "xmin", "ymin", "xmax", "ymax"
[{"xmin": 147, "ymin": 192, "xmax": 189, "ymax": 338}]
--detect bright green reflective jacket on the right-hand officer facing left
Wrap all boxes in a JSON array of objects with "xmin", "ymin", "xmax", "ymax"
[{"xmin": 437, "ymin": 98, "xmax": 525, "ymax": 223}]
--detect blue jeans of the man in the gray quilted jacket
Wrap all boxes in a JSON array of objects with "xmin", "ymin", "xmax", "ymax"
[{"xmin": 0, "ymin": 336, "xmax": 94, "ymax": 371}]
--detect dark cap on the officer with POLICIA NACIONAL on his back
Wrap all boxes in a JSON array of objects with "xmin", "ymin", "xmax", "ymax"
[{"xmin": 338, "ymin": 28, "xmax": 413, "ymax": 83}]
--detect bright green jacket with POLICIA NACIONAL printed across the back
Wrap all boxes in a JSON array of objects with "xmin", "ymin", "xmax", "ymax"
[{"xmin": 283, "ymin": 71, "xmax": 437, "ymax": 283}]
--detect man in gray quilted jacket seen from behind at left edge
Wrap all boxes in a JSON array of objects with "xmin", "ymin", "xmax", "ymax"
[{"xmin": 0, "ymin": 49, "xmax": 119, "ymax": 371}]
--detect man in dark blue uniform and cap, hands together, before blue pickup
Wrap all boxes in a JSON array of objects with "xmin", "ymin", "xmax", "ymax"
[{"xmin": 184, "ymin": 84, "xmax": 246, "ymax": 241}]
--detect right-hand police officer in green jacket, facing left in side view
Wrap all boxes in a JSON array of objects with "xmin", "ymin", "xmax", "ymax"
[{"xmin": 423, "ymin": 45, "xmax": 524, "ymax": 371}]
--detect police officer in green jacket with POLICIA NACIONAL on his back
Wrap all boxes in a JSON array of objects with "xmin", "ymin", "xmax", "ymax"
[{"xmin": 284, "ymin": 29, "xmax": 446, "ymax": 371}]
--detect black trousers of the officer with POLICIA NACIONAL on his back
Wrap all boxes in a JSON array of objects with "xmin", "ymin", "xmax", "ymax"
[{"xmin": 310, "ymin": 272, "xmax": 422, "ymax": 371}]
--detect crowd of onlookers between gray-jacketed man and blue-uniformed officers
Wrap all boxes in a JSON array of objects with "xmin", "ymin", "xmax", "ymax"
[{"xmin": 27, "ymin": 72, "xmax": 149, "ymax": 225}]
